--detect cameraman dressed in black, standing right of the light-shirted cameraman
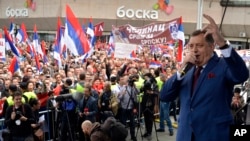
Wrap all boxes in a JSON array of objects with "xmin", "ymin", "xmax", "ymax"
[{"xmin": 141, "ymin": 73, "xmax": 159, "ymax": 137}]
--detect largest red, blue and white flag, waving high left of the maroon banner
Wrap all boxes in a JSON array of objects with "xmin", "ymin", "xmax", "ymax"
[{"xmin": 64, "ymin": 5, "xmax": 90, "ymax": 56}]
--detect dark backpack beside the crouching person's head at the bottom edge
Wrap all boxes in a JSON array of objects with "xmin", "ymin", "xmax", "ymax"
[{"xmin": 101, "ymin": 117, "xmax": 128, "ymax": 141}]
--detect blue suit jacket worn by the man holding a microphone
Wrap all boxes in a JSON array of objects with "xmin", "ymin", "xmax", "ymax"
[{"xmin": 160, "ymin": 49, "xmax": 249, "ymax": 141}]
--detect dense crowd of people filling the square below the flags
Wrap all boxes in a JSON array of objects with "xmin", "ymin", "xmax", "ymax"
[{"xmin": 0, "ymin": 37, "xmax": 181, "ymax": 140}]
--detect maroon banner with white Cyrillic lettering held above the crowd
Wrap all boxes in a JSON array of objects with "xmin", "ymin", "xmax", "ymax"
[{"xmin": 112, "ymin": 18, "xmax": 181, "ymax": 45}]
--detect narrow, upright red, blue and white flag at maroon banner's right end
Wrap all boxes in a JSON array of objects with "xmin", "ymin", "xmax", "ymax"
[{"xmin": 176, "ymin": 17, "xmax": 185, "ymax": 62}]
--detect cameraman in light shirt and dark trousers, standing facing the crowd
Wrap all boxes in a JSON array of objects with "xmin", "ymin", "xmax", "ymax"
[{"xmin": 118, "ymin": 75, "xmax": 139, "ymax": 141}]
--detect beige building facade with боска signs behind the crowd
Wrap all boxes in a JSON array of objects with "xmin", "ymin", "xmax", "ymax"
[{"xmin": 0, "ymin": 0, "xmax": 250, "ymax": 48}]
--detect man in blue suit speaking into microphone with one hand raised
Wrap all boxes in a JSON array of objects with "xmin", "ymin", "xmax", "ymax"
[{"xmin": 160, "ymin": 14, "xmax": 249, "ymax": 141}]
